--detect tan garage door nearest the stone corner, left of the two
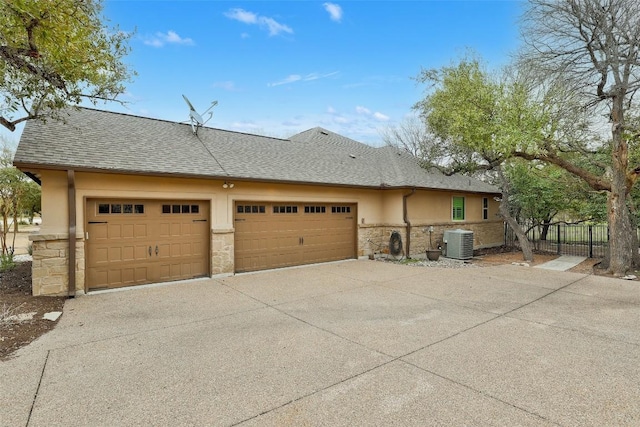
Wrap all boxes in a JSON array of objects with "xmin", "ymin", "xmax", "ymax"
[{"xmin": 85, "ymin": 199, "xmax": 209, "ymax": 290}]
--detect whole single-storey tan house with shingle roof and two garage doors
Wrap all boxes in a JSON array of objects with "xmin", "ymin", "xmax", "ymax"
[{"xmin": 14, "ymin": 108, "xmax": 503, "ymax": 295}]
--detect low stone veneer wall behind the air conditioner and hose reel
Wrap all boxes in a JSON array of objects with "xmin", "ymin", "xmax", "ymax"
[{"xmin": 358, "ymin": 221, "xmax": 504, "ymax": 256}]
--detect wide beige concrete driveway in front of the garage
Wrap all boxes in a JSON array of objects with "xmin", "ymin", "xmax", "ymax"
[{"xmin": 0, "ymin": 261, "xmax": 640, "ymax": 426}]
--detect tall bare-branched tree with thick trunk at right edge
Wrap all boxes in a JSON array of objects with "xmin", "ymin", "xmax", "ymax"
[{"xmin": 520, "ymin": 0, "xmax": 640, "ymax": 276}]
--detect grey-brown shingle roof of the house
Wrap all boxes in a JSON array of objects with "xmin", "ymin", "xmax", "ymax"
[{"xmin": 14, "ymin": 108, "xmax": 499, "ymax": 193}]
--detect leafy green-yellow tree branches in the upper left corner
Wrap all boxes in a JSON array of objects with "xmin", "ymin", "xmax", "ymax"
[{"xmin": 0, "ymin": 0, "xmax": 132, "ymax": 131}]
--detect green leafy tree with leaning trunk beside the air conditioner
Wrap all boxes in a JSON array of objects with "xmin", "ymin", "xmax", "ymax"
[{"xmin": 414, "ymin": 57, "xmax": 536, "ymax": 260}]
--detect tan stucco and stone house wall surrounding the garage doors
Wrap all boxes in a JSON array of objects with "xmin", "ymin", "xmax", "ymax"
[{"xmin": 34, "ymin": 170, "xmax": 503, "ymax": 292}]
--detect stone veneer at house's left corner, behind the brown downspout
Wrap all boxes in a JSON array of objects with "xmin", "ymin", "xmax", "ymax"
[{"xmin": 29, "ymin": 234, "xmax": 84, "ymax": 296}]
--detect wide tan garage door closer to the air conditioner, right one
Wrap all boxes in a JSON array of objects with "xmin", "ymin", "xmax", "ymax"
[{"xmin": 234, "ymin": 202, "xmax": 356, "ymax": 272}]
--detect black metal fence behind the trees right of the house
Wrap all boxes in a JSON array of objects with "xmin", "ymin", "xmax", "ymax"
[{"xmin": 504, "ymin": 223, "xmax": 609, "ymax": 258}]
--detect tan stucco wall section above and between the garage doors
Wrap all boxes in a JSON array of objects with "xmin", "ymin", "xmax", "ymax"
[{"xmin": 41, "ymin": 171, "xmax": 390, "ymax": 234}]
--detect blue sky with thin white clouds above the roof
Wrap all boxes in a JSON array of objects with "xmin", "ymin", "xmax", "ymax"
[{"xmin": 5, "ymin": 0, "xmax": 523, "ymax": 145}]
